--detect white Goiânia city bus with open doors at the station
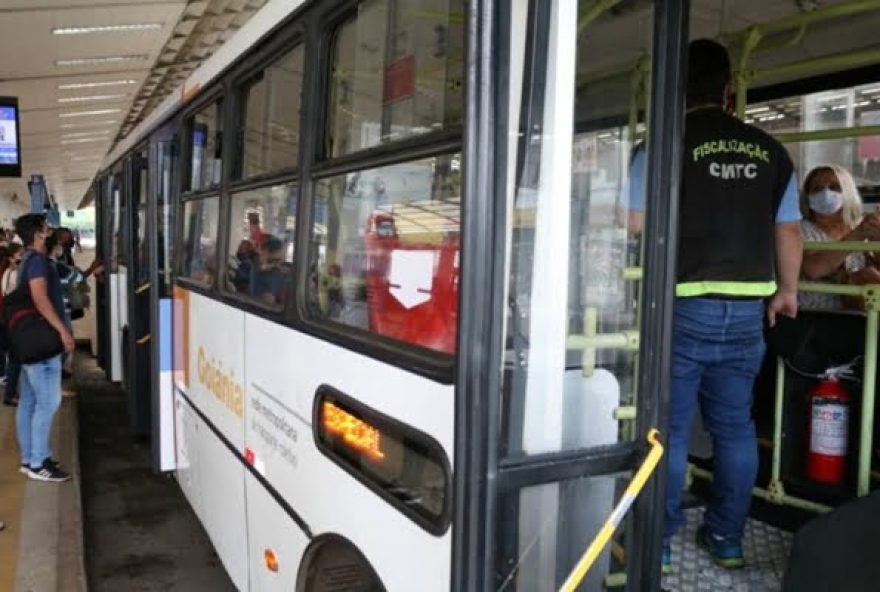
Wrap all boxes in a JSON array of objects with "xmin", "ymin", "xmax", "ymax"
[{"xmin": 93, "ymin": 0, "xmax": 880, "ymax": 591}]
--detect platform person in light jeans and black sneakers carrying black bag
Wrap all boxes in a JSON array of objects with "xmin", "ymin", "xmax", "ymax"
[{"xmin": 15, "ymin": 214, "xmax": 74, "ymax": 481}]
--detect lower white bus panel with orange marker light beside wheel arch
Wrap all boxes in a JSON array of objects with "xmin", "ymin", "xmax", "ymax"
[{"xmin": 245, "ymin": 473, "xmax": 309, "ymax": 592}]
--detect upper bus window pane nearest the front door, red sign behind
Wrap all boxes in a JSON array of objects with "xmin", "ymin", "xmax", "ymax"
[{"xmin": 326, "ymin": 0, "xmax": 464, "ymax": 158}]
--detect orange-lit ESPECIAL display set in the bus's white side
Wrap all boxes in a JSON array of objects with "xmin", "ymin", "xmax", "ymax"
[{"xmin": 314, "ymin": 387, "xmax": 451, "ymax": 534}]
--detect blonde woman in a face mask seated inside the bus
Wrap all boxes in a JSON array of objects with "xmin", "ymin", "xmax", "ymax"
[{"xmin": 800, "ymin": 165, "xmax": 880, "ymax": 310}]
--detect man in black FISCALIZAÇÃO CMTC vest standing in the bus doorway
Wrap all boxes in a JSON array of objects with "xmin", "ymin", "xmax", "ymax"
[{"xmin": 663, "ymin": 40, "xmax": 801, "ymax": 571}]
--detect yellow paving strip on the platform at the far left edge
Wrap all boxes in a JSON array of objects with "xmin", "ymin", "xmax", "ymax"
[{"xmin": 0, "ymin": 406, "xmax": 27, "ymax": 590}]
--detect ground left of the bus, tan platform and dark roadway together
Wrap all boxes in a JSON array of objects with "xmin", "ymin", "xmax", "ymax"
[{"xmin": 0, "ymin": 343, "xmax": 235, "ymax": 592}]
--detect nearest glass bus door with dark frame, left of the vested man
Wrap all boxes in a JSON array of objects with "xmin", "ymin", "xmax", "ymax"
[{"xmin": 454, "ymin": 0, "xmax": 687, "ymax": 591}]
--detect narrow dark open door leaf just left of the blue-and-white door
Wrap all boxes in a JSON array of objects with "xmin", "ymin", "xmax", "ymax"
[{"xmin": 120, "ymin": 146, "xmax": 152, "ymax": 435}]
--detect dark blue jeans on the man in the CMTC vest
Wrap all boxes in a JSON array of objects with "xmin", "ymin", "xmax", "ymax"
[{"xmin": 665, "ymin": 298, "xmax": 765, "ymax": 538}]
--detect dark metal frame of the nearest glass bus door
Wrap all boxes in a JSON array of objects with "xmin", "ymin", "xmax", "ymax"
[{"xmin": 452, "ymin": 0, "xmax": 690, "ymax": 592}]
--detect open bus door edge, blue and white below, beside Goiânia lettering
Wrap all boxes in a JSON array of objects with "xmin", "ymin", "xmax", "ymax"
[{"xmin": 145, "ymin": 131, "xmax": 177, "ymax": 471}]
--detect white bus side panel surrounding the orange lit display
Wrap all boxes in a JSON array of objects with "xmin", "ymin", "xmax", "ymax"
[{"xmin": 245, "ymin": 315, "xmax": 454, "ymax": 590}]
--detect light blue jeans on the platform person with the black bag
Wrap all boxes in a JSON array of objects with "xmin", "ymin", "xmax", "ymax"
[{"xmin": 17, "ymin": 354, "xmax": 61, "ymax": 468}]
